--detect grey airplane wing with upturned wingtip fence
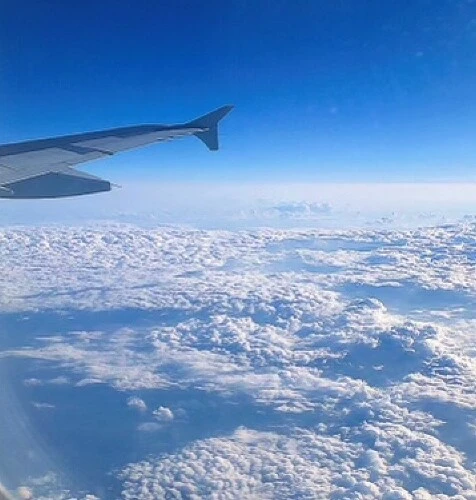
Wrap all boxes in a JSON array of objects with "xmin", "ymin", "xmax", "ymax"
[{"xmin": 0, "ymin": 106, "xmax": 233, "ymax": 199}]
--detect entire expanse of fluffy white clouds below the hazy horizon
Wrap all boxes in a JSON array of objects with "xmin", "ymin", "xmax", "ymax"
[{"xmin": 0, "ymin": 223, "xmax": 476, "ymax": 499}]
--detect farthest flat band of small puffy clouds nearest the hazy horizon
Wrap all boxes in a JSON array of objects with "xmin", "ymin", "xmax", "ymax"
[{"xmin": 0, "ymin": 223, "xmax": 476, "ymax": 312}]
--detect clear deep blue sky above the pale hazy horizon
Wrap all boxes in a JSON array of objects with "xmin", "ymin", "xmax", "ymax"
[{"xmin": 0, "ymin": 0, "xmax": 476, "ymax": 181}]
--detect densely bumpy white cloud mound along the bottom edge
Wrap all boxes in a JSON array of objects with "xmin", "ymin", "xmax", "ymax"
[{"xmin": 120, "ymin": 428, "xmax": 474, "ymax": 499}]
